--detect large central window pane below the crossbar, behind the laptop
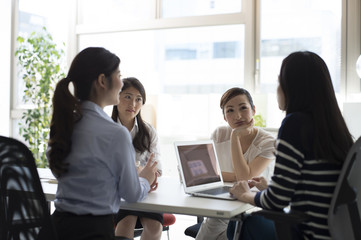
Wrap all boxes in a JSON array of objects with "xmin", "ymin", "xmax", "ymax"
[{"xmin": 79, "ymin": 25, "xmax": 244, "ymax": 137}]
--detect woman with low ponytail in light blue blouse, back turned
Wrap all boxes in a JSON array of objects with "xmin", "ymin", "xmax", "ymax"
[{"xmin": 48, "ymin": 47, "xmax": 157, "ymax": 240}]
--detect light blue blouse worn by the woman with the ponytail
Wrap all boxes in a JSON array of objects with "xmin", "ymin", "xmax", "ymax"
[{"xmin": 55, "ymin": 101, "xmax": 150, "ymax": 215}]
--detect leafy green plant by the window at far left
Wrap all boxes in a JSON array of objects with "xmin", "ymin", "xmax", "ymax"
[{"xmin": 15, "ymin": 28, "xmax": 65, "ymax": 167}]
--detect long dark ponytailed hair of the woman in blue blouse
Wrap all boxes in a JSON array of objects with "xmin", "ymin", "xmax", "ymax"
[{"xmin": 49, "ymin": 47, "xmax": 120, "ymax": 177}]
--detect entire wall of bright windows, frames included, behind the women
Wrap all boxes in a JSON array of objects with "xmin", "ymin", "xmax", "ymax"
[{"xmin": 7, "ymin": 0, "xmax": 360, "ymax": 175}]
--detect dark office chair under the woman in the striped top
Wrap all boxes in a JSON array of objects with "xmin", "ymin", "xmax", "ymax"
[{"xmin": 252, "ymin": 138, "xmax": 361, "ymax": 240}]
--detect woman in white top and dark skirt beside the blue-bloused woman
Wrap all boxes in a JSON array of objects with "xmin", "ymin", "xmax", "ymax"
[{"xmin": 112, "ymin": 78, "xmax": 163, "ymax": 240}]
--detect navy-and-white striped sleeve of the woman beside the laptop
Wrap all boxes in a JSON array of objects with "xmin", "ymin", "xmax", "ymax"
[{"xmin": 255, "ymin": 114, "xmax": 304, "ymax": 209}]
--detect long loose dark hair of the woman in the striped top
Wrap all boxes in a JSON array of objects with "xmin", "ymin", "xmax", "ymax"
[{"xmin": 279, "ymin": 51, "xmax": 353, "ymax": 162}]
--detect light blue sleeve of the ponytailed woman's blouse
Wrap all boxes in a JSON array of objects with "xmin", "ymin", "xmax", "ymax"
[{"xmin": 113, "ymin": 129, "xmax": 150, "ymax": 202}]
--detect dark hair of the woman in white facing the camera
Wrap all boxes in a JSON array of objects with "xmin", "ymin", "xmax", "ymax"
[{"xmin": 112, "ymin": 77, "xmax": 151, "ymax": 153}]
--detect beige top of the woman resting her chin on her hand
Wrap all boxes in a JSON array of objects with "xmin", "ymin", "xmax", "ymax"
[{"xmin": 211, "ymin": 126, "xmax": 275, "ymax": 180}]
